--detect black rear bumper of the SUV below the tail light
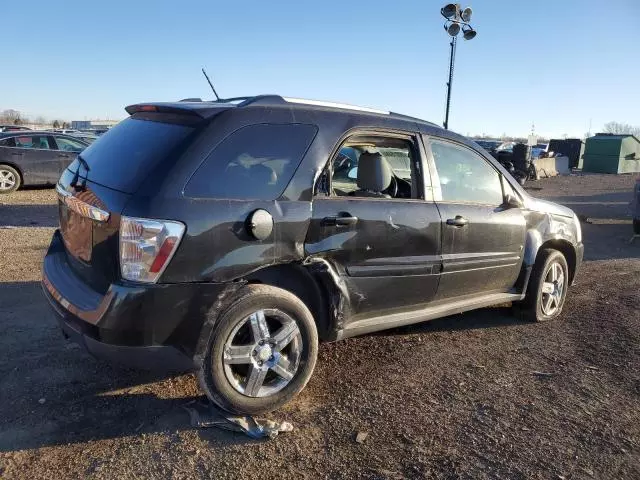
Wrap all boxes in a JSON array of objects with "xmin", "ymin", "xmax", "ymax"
[{"xmin": 42, "ymin": 231, "xmax": 226, "ymax": 371}]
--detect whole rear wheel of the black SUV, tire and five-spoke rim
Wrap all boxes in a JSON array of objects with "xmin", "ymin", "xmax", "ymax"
[{"xmin": 198, "ymin": 285, "xmax": 318, "ymax": 415}]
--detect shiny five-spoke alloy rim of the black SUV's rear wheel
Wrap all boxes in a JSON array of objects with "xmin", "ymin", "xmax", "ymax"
[{"xmin": 222, "ymin": 309, "xmax": 303, "ymax": 397}]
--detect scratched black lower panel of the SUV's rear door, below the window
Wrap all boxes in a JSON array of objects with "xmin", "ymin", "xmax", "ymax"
[{"xmin": 305, "ymin": 197, "xmax": 441, "ymax": 320}]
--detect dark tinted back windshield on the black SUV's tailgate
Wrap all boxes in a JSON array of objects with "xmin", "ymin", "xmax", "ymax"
[{"xmin": 72, "ymin": 113, "xmax": 194, "ymax": 193}]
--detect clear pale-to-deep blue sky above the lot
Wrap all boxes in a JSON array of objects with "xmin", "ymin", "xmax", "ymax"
[{"xmin": 0, "ymin": 0, "xmax": 640, "ymax": 136}]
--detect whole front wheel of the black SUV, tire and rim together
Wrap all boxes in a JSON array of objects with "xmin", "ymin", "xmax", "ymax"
[{"xmin": 518, "ymin": 248, "xmax": 569, "ymax": 322}]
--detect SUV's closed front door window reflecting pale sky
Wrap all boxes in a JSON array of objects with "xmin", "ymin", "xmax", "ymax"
[{"xmin": 430, "ymin": 140, "xmax": 503, "ymax": 205}]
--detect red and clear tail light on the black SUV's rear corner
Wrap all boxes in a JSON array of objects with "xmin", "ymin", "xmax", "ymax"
[{"xmin": 120, "ymin": 216, "xmax": 184, "ymax": 283}]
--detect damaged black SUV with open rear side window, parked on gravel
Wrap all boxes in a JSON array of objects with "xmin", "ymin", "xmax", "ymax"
[{"xmin": 42, "ymin": 95, "xmax": 583, "ymax": 414}]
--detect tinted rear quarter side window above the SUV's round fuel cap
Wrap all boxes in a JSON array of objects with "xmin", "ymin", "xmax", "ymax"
[{"xmin": 185, "ymin": 124, "xmax": 318, "ymax": 200}]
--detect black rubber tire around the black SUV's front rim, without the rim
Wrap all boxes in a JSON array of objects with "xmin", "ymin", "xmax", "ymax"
[{"xmin": 516, "ymin": 248, "xmax": 569, "ymax": 322}]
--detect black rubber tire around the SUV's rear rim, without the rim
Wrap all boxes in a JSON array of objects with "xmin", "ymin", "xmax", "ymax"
[{"xmin": 197, "ymin": 285, "xmax": 318, "ymax": 415}]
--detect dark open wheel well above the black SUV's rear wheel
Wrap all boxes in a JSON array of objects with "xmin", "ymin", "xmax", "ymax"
[{"xmin": 244, "ymin": 263, "xmax": 331, "ymax": 339}]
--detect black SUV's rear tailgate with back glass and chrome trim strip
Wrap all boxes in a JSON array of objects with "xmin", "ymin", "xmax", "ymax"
[{"xmin": 57, "ymin": 108, "xmax": 215, "ymax": 294}]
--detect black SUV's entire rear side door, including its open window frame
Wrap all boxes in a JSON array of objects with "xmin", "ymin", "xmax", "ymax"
[{"xmin": 305, "ymin": 131, "xmax": 441, "ymax": 321}]
